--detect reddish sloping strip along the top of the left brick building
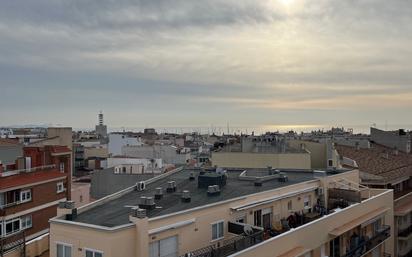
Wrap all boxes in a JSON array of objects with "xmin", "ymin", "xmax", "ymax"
[{"xmin": 0, "ymin": 170, "xmax": 67, "ymax": 190}]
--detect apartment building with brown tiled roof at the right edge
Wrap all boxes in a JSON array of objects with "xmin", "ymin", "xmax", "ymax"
[{"xmin": 337, "ymin": 143, "xmax": 412, "ymax": 257}]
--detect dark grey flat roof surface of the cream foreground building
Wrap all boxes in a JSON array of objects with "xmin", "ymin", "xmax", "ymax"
[{"xmin": 69, "ymin": 169, "xmax": 348, "ymax": 227}]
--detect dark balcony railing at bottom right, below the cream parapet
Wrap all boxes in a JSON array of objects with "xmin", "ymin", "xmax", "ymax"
[{"xmin": 342, "ymin": 226, "xmax": 391, "ymax": 257}]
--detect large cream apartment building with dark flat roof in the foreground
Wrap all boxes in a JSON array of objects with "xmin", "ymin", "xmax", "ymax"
[{"xmin": 50, "ymin": 164, "xmax": 394, "ymax": 257}]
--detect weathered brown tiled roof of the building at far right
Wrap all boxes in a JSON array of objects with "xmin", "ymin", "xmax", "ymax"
[{"xmin": 336, "ymin": 144, "xmax": 412, "ymax": 183}]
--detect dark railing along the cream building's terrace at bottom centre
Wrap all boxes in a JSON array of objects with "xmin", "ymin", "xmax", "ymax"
[{"xmin": 180, "ymin": 231, "xmax": 263, "ymax": 257}]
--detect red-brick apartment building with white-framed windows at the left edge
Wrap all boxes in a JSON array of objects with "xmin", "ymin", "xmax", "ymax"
[{"xmin": 0, "ymin": 146, "xmax": 71, "ymax": 256}]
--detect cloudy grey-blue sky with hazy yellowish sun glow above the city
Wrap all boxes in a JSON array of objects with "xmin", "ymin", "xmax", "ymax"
[{"xmin": 0, "ymin": 0, "xmax": 412, "ymax": 131}]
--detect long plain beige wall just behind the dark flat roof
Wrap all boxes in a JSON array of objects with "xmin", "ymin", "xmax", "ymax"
[{"xmin": 211, "ymin": 152, "xmax": 311, "ymax": 169}]
